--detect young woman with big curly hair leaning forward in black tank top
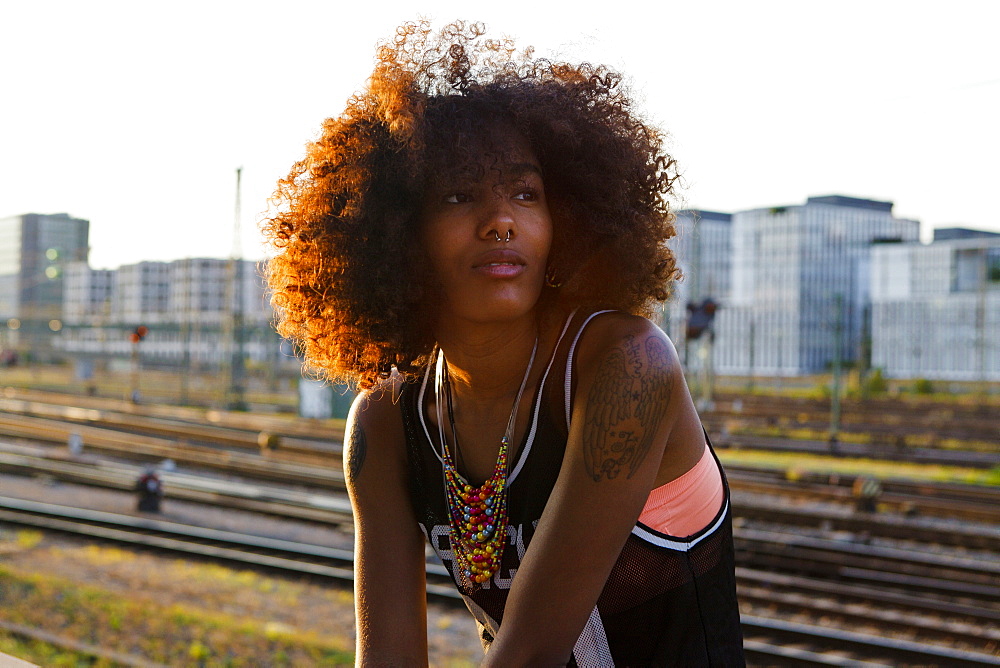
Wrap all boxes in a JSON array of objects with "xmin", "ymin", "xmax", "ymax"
[{"xmin": 265, "ymin": 23, "xmax": 743, "ymax": 666}]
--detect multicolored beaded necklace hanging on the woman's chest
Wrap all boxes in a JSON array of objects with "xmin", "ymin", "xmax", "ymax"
[{"xmin": 434, "ymin": 338, "xmax": 538, "ymax": 589}]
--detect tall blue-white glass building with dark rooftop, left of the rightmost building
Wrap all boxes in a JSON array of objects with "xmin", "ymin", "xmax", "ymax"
[{"xmin": 701, "ymin": 195, "xmax": 919, "ymax": 375}]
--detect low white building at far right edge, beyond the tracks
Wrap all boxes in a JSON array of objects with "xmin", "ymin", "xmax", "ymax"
[{"xmin": 871, "ymin": 230, "xmax": 1000, "ymax": 381}]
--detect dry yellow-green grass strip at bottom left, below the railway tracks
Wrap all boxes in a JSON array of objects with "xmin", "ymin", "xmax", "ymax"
[{"xmin": 0, "ymin": 531, "xmax": 482, "ymax": 667}]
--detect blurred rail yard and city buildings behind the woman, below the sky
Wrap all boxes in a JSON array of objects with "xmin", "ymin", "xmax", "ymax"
[{"xmin": 0, "ymin": 200, "xmax": 1000, "ymax": 666}]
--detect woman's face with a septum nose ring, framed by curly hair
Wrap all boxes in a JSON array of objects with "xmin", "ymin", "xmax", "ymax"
[{"xmin": 422, "ymin": 140, "xmax": 552, "ymax": 323}]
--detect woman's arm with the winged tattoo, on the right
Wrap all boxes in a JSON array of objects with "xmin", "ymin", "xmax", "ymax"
[{"xmin": 484, "ymin": 314, "xmax": 704, "ymax": 666}]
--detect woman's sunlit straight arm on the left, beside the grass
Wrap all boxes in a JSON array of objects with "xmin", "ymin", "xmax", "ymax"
[{"xmin": 344, "ymin": 388, "xmax": 427, "ymax": 666}]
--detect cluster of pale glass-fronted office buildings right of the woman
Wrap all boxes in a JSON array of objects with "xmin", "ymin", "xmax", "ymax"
[{"xmin": 664, "ymin": 195, "xmax": 1000, "ymax": 383}]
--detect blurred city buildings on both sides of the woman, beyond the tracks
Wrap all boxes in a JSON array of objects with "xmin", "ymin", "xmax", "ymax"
[{"xmin": 0, "ymin": 195, "xmax": 1000, "ymax": 414}]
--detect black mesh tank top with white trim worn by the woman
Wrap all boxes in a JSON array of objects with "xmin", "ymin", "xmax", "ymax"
[{"xmin": 400, "ymin": 313, "xmax": 744, "ymax": 666}]
